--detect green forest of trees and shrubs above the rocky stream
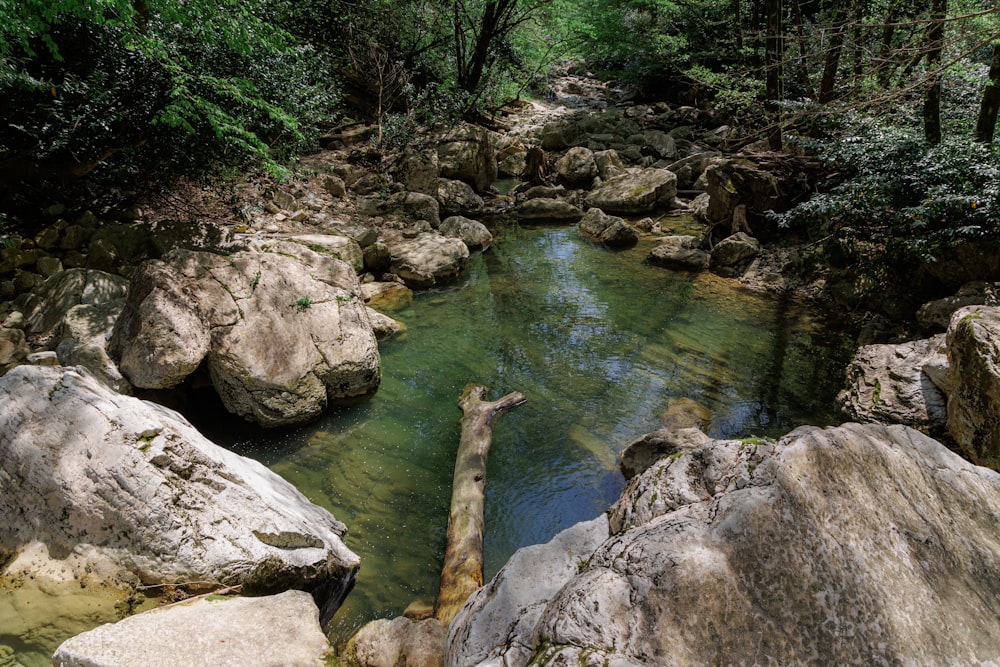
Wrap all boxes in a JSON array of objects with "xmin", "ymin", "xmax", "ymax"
[{"xmin": 0, "ymin": 0, "xmax": 1000, "ymax": 292}]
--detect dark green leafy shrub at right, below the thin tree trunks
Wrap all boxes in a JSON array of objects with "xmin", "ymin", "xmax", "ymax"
[{"xmin": 772, "ymin": 118, "xmax": 1000, "ymax": 291}]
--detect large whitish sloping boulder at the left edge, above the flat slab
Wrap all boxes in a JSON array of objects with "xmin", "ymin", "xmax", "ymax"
[{"xmin": 0, "ymin": 366, "xmax": 359, "ymax": 618}]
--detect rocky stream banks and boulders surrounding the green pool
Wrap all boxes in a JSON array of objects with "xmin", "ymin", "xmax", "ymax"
[{"xmin": 0, "ymin": 70, "xmax": 1000, "ymax": 666}]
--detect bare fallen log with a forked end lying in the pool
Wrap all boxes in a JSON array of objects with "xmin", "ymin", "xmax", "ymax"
[{"xmin": 434, "ymin": 384, "xmax": 526, "ymax": 627}]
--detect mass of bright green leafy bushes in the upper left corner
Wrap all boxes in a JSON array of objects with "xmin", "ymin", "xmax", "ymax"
[{"xmin": 0, "ymin": 0, "xmax": 340, "ymax": 190}]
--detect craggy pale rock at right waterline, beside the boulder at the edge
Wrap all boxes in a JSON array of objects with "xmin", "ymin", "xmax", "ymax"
[{"xmin": 837, "ymin": 334, "xmax": 948, "ymax": 435}]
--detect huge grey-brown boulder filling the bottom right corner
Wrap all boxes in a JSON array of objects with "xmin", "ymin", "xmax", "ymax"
[{"xmin": 446, "ymin": 424, "xmax": 1000, "ymax": 667}]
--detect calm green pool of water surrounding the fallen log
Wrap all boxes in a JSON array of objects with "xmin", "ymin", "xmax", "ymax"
[{"xmin": 193, "ymin": 226, "xmax": 850, "ymax": 641}]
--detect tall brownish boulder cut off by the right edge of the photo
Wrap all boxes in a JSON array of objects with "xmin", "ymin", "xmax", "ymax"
[{"xmin": 947, "ymin": 306, "xmax": 1000, "ymax": 470}]
